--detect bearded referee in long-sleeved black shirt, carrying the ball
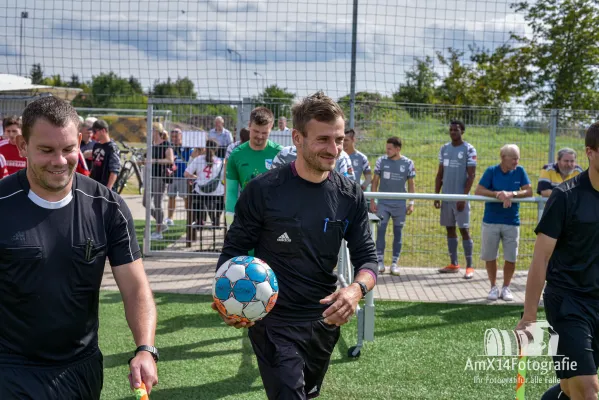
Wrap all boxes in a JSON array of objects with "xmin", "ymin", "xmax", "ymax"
[{"xmin": 213, "ymin": 92, "xmax": 377, "ymax": 400}]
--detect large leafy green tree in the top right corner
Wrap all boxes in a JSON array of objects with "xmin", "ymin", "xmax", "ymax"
[{"xmin": 512, "ymin": 0, "xmax": 599, "ymax": 109}]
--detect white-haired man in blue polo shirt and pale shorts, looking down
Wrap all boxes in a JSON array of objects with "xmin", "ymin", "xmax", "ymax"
[{"xmin": 475, "ymin": 144, "xmax": 532, "ymax": 301}]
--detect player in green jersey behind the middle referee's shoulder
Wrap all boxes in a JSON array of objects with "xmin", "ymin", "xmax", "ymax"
[{"xmin": 225, "ymin": 107, "xmax": 282, "ymax": 226}]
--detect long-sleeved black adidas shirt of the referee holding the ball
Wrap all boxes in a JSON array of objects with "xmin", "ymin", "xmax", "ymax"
[{"xmin": 217, "ymin": 163, "xmax": 377, "ymax": 321}]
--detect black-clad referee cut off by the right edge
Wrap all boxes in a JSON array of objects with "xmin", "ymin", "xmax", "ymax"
[{"xmin": 516, "ymin": 123, "xmax": 599, "ymax": 400}]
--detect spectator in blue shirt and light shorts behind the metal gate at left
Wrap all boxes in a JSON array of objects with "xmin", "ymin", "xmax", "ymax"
[{"xmin": 164, "ymin": 128, "xmax": 192, "ymax": 226}]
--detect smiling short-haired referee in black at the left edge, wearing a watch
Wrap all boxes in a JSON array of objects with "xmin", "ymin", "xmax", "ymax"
[{"xmin": 0, "ymin": 97, "xmax": 158, "ymax": 400}]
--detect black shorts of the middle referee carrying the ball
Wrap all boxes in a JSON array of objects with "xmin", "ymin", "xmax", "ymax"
[{"xmin": 248, "ymin": 318, "xmax": 341, "ymax": 400}]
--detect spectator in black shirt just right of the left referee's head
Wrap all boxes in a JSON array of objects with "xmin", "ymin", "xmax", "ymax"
[{"xmin": 89, "ymin": 119, "xmax": 121, "ymax": 190}]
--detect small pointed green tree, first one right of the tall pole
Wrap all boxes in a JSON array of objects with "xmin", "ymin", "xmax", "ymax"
[{"xmin": 393, "ymin": 56, "xmax": 439, "ymax": 104}]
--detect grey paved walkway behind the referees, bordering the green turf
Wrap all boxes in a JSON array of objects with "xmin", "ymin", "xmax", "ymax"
[{"xmin": 116, "ymin": 195, "xmax": 527, "ymax": 305}]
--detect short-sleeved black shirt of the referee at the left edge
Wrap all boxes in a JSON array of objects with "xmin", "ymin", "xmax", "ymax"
[{"xmin": 0, "ymin": 170, "xmax": 141, "ymax": 366}]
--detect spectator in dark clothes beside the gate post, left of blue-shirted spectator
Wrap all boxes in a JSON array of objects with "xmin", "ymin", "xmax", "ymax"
[{"xmin": 143, "ymin": 122, "xmax": 175, "ymax": 240}]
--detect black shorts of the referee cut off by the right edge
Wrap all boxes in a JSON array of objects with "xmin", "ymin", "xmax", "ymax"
[{"xmin": 543, "ymin": 290, "xmax": 599, "ymax": 379}]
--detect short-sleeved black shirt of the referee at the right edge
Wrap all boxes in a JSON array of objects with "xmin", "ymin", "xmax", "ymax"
[{"xmin": 535, "ymin": 170, "xmax": 599, "ymax": 299}]
